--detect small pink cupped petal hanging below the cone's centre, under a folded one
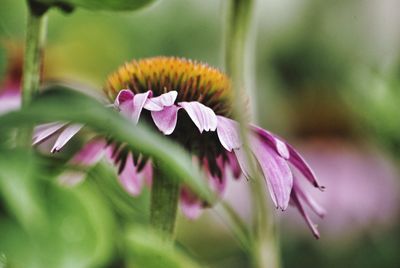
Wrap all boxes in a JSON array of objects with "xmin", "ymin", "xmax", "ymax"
[{"xmin": 151, "ymin": 105, "xmax": 181, "ymax": 135}]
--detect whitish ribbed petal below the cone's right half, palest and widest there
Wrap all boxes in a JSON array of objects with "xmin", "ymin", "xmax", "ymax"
[{"xmin": 178, "ymin": 101, "xmax": 217, "ymax": 133}]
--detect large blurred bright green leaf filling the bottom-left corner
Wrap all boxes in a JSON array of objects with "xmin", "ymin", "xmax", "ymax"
[{"xmin": 0, "ymin": 148, "xmax": 115, "ymax": 268}]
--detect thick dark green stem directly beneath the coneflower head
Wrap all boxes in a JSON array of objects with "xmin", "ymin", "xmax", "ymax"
[{"xmin": 150, "ymin": 168, "xmax": 179, "ymax": 243}]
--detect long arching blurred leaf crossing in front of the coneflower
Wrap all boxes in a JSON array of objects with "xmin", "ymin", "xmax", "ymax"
[{"xmin": 0, "ymin": 86, "xmax": 215, "ymax": 204}]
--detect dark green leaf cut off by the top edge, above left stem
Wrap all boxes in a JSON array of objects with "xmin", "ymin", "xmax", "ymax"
[{"xmin": 31, "ymin": 0, "xmax": 156, "ymax": 11}]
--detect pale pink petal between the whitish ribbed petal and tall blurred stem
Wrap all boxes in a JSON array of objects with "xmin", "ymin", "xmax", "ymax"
[{"xmin": 217, "ymin": 116, "xmax": 242, "ymax": 152}]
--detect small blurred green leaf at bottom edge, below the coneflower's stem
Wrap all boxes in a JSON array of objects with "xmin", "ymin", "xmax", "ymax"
[{"xmin": 125, "ymin": 228, "xmax": 201, "ymax": 268}]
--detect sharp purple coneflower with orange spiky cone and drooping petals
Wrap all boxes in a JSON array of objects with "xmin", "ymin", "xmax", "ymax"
[{"xmin": 34, "ymin": 57, "xmax": 324, "ymax": 237}]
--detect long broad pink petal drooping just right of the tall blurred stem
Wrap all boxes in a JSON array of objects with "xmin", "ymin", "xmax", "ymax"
[{"xmin": 251, "ymin": 137, "xmax": 293, "ymax": 210}]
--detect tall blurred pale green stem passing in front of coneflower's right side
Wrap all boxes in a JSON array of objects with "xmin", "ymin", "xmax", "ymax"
[{"xmin": 225, "ymin": 0, "xmax": 280, "ymax": 267}]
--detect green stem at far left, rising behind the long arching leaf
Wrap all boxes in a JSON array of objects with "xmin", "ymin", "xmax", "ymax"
[{"xmin": 18, "ymin": 2, "xmax": 47, "ymax": 147}]
